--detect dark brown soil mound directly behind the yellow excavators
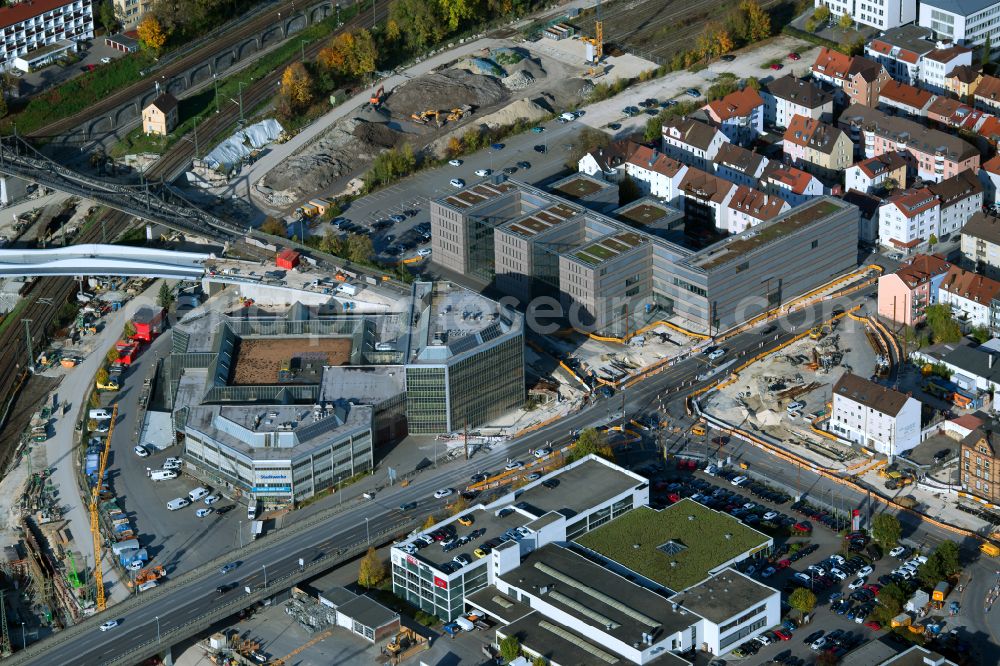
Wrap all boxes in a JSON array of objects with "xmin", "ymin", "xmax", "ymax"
[{"xmin": 385, "ymin": 69, "xmax": 508, "ymax": 118}]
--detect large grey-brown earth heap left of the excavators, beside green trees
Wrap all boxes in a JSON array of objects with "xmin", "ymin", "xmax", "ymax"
[{"xmin": 255, "ymin": 118, "xmax": 402, "ymax": 207}]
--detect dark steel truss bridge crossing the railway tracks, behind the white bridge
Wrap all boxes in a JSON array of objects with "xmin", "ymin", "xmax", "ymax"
[{"xmin": 0, "ymin": 135, "xmax": 242, "ymax": 240}]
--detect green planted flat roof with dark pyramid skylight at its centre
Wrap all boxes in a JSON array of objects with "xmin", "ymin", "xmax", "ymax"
[{"xmin": 576, "ymin": 499, "xmax": 772, "ymax": 592}]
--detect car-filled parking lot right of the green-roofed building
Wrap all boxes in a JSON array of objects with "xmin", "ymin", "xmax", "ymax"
[{"xmin": 644, "ymin": 462, "xmax": 963, "ymax": 666}]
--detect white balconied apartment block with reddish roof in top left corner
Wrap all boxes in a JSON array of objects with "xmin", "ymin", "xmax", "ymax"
[{"xmin": 0, "ymin": 0, "xmax": 94, "ymax": 72}]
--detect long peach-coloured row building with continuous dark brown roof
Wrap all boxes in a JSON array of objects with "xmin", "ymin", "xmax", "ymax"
[{"xmin": 839, "ymin": 104, "xmax": 979, "ymax": 182}]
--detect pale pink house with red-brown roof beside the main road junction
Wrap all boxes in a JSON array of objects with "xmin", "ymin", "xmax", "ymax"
[{"xmin": 878, "ymin": 254, "xmax": 952, "ymax": 326}]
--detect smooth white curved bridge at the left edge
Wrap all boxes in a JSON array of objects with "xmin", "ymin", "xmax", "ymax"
[{"xmin": 0, "ymin": 243, "xmax": 211, "ymax": 280}]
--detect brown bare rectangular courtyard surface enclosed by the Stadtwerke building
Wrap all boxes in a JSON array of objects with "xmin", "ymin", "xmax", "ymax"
[{"xmin": 229, "ymin": 337, "xmax": 351, "ymax": 386}]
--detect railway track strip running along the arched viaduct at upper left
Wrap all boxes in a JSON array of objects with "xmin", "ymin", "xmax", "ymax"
[{"xmin": 28, "ymin": 0, "xmax": 338, "ymax": 139}]
